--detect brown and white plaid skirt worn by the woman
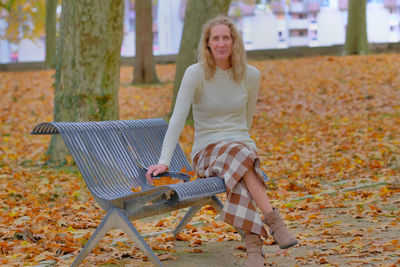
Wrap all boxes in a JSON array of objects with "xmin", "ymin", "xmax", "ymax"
[{"xmin": 193, "ymin": 142, "xmax": 268, "ymax": 237}]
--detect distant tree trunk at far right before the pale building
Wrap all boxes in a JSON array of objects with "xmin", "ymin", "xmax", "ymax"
[{"xmin": 344, "ymin": 0, "xmax": 369, "ymax": 55}]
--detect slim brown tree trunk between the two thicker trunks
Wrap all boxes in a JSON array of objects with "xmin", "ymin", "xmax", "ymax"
[{"xmin": 133, "ymin": 0, "xmax": 158, "ymax": 83}]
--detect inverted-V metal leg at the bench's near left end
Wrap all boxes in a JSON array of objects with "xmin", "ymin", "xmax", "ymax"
[{"xmin": 71, "ymin": 209, "xmax": 163, "ymax": 267}]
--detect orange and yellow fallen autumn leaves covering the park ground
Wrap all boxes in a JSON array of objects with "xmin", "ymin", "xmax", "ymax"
[{"xmin": 0, "ymin": 54, "xmax": 400, "ymax": 266}]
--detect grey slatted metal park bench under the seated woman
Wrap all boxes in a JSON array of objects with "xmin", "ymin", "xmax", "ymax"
[{"xmin": 31, "ymin": 119, "xmax": 268, "ymax": 266}]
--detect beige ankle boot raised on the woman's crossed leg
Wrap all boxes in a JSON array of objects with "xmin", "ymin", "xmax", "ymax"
[{"xmin": 264, "ymin": 208, "xmax": 298, "ymax": 249}]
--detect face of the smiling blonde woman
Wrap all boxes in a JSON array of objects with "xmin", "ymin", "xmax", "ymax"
[{"xmin": 207, "ymin": 24, "xmax": 233, "ymax": 66}]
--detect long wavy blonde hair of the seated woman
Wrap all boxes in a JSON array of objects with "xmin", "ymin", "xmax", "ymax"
[{"xmin": 197, "ymin": 15, "xmax": 247, "ymax": 82}]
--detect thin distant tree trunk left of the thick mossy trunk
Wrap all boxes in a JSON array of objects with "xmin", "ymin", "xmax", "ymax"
[{"xmin": 45, "ymin": 0, "xmax": 58, "ymax": 68}]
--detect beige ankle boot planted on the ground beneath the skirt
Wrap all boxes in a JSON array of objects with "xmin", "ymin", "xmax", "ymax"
[{"xmin": 244, "ymin": 233, "xmax": 264, "ymax": 267}]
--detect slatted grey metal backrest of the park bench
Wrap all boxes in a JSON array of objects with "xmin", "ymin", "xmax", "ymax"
[{"xmin": 32, "ymin": 119, "xmax": 192, "ymax": 203}]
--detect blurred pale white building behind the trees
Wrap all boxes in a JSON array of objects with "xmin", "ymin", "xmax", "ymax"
[{"xmin": 0, "ymin": 0, "xmax": 400, "ymax": 63}]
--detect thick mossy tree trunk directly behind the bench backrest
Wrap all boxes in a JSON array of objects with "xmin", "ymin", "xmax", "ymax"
[{"xmin": 48, "ymin": 0, "xmax": 124, "ymax": 165}]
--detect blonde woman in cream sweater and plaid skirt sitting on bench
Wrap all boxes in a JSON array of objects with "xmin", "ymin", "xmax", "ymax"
[{"xmin": 147, "ymin": 16, "xmax": 297, "ymax": 267}]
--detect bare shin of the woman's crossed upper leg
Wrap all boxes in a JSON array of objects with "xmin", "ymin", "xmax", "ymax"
[{"xmin": 243, "ymin": 169, "xmax": 272, "ymax": 214}]
